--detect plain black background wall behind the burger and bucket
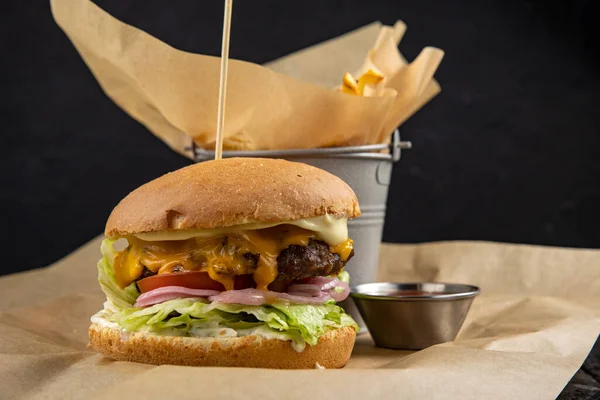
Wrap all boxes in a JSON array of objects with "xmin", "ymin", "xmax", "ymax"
[{"xmin": 0, "ymin": 0, "xmax": 600, "ymax": 273}]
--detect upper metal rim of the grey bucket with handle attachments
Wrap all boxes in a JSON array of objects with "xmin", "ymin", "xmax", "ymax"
[{"xmin": 185, "ymin": 129, "xmax": 412, "ymax": 162}]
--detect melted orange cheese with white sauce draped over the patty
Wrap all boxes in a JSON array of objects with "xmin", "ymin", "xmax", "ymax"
[{"xmin": 114, "ymin": 217, "xmax": 353, "ymax": 290}]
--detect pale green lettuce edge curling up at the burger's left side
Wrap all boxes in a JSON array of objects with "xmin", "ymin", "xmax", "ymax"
[{"xmin": 98, "ymin": 239, "xmax": 140, "ymax": 308}]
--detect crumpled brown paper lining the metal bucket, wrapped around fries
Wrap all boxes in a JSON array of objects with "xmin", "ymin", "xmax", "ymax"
[{"xmin": 51, "ymin": 0, "xmax": 443, "ymax": 157}]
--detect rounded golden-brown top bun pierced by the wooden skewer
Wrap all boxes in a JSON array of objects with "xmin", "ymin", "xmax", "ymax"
[{"xmin": 105, "ymin": 158, "xmax": 360, "ymax": 238}]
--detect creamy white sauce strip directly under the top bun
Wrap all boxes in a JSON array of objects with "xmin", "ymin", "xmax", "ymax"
[{"xmin": 135, "ymin": 214, "xmax": 348, "ymax": 246}]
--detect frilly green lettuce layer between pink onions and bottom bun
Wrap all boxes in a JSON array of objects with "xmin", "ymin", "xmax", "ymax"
[{"xmin": 109, "ymin": 299, "xmax": 358, "ymax": 351}]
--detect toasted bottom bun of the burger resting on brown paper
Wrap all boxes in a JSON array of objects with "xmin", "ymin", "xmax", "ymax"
[{"xmin": 89, "ymin": 324, "xmax": 356, "ymax": 369}]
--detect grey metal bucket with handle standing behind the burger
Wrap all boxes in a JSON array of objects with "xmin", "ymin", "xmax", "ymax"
[{"xmin": 191, "ymin": 130, "xmax": 411, "ymax": 330}]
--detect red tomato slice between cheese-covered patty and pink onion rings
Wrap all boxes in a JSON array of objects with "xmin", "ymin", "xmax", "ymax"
[{"xmin": 137, "ymin": 271, "xmax": 288, "ymax": 293}]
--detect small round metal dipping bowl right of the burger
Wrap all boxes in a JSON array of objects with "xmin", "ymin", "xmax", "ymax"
[{"xmin": 350, "ymin": 283, "xmax": 480, "ymax": 350}]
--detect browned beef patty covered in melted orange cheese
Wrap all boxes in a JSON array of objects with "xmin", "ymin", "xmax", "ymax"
[{"xmin": 115, "ymin": 225, "xmax": 354, "ymax": 290}]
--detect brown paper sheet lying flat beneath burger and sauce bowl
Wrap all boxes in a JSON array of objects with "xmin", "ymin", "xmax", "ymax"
[{"xmin": 0, "ymin": 238, "xmax": 600, "ymax": 399}]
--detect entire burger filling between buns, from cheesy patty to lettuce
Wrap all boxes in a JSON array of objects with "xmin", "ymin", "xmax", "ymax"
[{"xmin": 92, "ymin": 221, "xmax": 358, "ymax": 351}]
